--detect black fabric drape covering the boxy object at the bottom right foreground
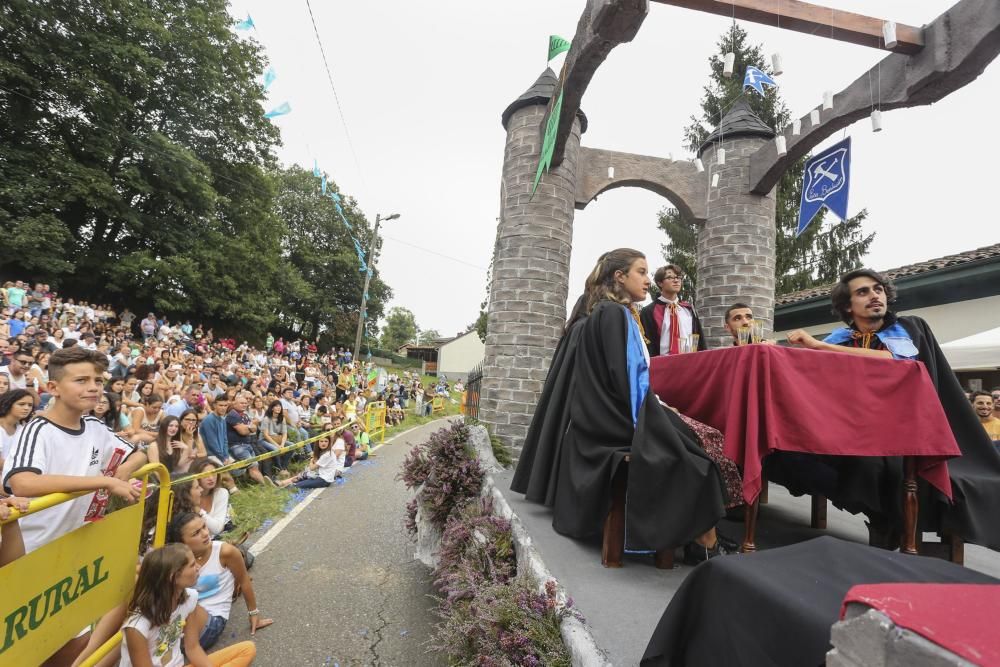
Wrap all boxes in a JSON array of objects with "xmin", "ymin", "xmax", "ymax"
[{"xmin": 642, "ymin": 536, "xmax": 1000, "ymax": 667}]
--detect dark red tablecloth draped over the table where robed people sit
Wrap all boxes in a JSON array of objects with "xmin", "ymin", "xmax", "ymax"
[{"xmin": 650, "ymin": 345, "xmax": 961, "ymax": 503}]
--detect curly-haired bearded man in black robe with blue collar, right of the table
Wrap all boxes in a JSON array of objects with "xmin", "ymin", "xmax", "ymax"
[{"xmin": 784, "ymin": 269, "xmax": 1000, "ymax": 550}]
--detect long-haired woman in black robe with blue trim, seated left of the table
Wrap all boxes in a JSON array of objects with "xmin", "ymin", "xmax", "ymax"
[{"xmin": 511, "ymin": 249, "xmax": 732, "ymax": 560}]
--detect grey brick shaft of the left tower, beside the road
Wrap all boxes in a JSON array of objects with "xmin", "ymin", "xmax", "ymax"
[{"xmin": 479, "ymin": 105, "xmax": 580, "ymax": 456}]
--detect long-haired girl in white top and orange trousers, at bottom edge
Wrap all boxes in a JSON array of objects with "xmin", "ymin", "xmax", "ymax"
[{"xmin": 121, "ymin": 544, "xmax": 264, "ymax": 667}]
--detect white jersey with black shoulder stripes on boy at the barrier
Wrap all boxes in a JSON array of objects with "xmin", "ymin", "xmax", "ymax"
[{"xmin": 3, "ymin": 416, "xmax": 135, "ymax": 552}]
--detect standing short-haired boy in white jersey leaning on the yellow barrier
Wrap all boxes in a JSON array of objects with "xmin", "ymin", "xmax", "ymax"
[{"xmin": 3, "ymin": 345, "xmax": 146, "ymax": 665}]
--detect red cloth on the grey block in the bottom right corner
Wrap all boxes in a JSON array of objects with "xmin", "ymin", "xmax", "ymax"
[{"xmin": 840, "ymin": 584, "xmax": 1000, "ymax": 665}]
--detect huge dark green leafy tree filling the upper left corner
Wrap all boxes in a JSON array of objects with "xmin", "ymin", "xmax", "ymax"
[{"xmin": 0, "ymin": 0, "xmax": 287, "ymax": 334}]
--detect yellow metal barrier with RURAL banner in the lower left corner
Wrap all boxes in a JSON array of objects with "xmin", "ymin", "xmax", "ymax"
[{"xmin": 0, "ymin": 464, "xmax": 170, "ymax": 665}]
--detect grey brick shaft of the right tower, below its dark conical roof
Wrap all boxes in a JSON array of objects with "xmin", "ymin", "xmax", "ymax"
[{"xmin": 695, "ymin": 137, "xmax": 775, "ymax": 348}]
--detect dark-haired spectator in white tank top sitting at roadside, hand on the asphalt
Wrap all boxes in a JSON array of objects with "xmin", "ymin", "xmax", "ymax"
[{"xmin": 167, "ymin": 512, "xmax": 274, "ymax": 650}]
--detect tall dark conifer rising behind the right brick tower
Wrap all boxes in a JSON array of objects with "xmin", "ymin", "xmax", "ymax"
[{"xmin": 657, "ymin": 26, "xmax": 875, "ymax": 294}]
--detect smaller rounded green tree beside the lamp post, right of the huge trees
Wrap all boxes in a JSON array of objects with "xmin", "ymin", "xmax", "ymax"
[{"xmin": 274, "ymin": 165, "xmax": 392, "ymax": 346}]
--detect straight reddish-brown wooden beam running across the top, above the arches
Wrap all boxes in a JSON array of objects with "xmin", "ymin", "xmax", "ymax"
[{"xmin": 655, "ymin": 0, "xmax": 924, "ymax": 54}]
